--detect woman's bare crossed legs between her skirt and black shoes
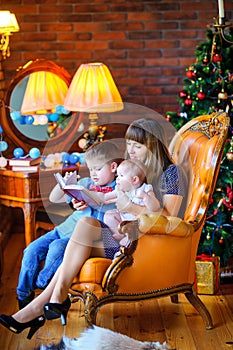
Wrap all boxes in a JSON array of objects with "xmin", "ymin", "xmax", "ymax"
[{"xmin": 12, "ymin": 218, "xmax": 104, "ymax": 322}]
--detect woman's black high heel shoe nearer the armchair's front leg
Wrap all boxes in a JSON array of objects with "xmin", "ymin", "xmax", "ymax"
[{"xmin": 44, "ymin": 297, "xmax": 71, "ymax": 326}]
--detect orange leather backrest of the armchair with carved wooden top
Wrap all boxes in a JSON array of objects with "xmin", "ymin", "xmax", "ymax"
[{"xmin": 169, "ymin": 113, "xmax": 229, "ymax": 230}]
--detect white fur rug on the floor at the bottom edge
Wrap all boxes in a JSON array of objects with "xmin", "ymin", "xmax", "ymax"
[{"xmin": 36, "ymin": 326, "xmax": 172, "ymax": 350}]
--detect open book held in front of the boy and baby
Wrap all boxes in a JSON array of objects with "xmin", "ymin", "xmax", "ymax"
[{"xmin": 54, "ymin": 171, "xmax": 102, "ymax": 206}]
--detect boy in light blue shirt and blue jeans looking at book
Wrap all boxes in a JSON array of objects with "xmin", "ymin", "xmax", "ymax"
[{"xmin": 16, "ymin": 141, "xmax": 119, "ymax": 309}]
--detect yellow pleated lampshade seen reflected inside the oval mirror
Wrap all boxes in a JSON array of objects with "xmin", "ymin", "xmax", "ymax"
[{"xmin": 21, "ymin": 71, "xmax": 68, "ymax": 115}]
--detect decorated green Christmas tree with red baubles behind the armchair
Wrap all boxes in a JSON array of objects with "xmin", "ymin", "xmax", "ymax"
[{"xmin": 167, "ymin": 26, "xmax": 233, "ymax": 266}]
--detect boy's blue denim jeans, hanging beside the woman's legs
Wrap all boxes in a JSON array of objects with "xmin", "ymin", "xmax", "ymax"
[{"xmin": 16, "ymin": 227, "xmax": 69, "ymax": 300}]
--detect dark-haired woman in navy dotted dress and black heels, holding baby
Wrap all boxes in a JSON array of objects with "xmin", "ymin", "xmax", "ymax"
[{"xmin": 0, "ymin": 119, "xmax": 185, "ymax": 337}]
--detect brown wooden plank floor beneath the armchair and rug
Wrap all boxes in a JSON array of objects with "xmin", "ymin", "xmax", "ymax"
[{"xmin": 0, "ymin": 234, "xmax": 233, "ymax": 350}]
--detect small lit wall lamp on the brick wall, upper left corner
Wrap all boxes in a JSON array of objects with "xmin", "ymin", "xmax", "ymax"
[{"xmin": 0, "ymin": 11, "xmax": 19, "ymax": 59}]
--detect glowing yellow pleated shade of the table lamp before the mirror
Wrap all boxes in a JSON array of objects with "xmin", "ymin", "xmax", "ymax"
[{"xmin": 64, "ymin": 63, "xmax": 123, "ymax": 113}]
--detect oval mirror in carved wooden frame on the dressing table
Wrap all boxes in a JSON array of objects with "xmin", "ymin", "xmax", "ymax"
[{"xmin": 2, "ymin": 59, "xmax": 83, "ymax": 151}]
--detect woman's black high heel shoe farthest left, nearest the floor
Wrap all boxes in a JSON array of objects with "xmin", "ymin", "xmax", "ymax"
[{"xmin": 0, "ymin": 314, "xmax": 45, "ymax": 339}]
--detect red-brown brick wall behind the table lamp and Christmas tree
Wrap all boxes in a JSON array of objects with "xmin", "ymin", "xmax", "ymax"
[{"xmin": 0, "ymin": 0, "xmax": 233, "ymax": 115}]
